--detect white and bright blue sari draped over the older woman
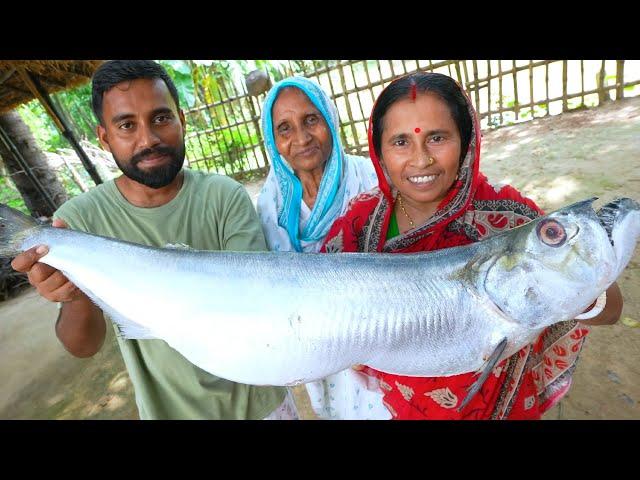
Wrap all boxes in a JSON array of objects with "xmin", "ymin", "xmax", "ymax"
[{"xmin": 257, "ymin": 77, "xmax": 391, "ymax": 420}]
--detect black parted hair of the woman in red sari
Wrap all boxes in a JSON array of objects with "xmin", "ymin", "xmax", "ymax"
[{"xmin": 371, "ymin": 72, "xmax": 472, "ymax": 161}]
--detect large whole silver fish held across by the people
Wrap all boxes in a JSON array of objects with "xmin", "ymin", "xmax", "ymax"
[{"xmin": 0, "ymin": 199, "xmax": 640, "ymax": 396}]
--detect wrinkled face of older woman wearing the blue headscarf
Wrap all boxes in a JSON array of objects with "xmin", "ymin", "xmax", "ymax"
[{"xmin": 272, "ymin": 87, "xmax": 333, "ymax": 173}]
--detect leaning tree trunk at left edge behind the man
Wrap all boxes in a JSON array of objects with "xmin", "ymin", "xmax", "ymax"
[{"xmin": 0, "ymin": 111, "xmax": 67, "ymax": 217}]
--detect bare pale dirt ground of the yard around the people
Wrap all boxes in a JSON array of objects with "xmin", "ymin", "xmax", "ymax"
[{"xmin": 0, "ymin": 97, "xmax": 640, "ymax": 419}]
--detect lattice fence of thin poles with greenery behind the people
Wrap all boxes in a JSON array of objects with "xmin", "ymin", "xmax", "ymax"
[{"xmin": 0, "ymin": 60, "xmax": 640, "ymax": 213}]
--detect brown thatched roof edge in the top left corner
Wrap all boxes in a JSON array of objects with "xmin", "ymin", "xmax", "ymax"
[{"xmin": 0, "ymin": 60, "xmax": 102, "ymax": 113}]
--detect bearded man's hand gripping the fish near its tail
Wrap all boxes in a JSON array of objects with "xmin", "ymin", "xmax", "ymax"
[{"xmin": 11, "ymin": 219, "xmax": 82, "ymax": 302}]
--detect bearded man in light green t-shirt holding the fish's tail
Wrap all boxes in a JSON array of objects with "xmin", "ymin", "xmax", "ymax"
[{"xmin": 12, "ymin": 60, "xmax": 295, "ymax": 419}]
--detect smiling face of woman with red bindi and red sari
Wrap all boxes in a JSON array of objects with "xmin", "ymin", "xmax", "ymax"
[{"xmin": 380, "ymin": 93, "xmax": 461, "ymax": 211}]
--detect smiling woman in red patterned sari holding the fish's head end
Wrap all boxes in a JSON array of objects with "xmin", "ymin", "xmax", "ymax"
[{"xmin": 322, "ymin": 73, "xmax": 622, "ymax": 419}]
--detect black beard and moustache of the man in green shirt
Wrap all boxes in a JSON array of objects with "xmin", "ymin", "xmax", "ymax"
[{"xmin": 113, "ymin": 143, "xmax": 185, "ymax": 188}]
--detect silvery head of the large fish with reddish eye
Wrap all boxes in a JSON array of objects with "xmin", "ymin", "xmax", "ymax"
[{"xmin": 479, "ymin": 198, "xmax": 640, "ymax": 329}]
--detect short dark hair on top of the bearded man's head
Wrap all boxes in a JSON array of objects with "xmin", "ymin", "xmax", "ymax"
[{"xmin": 91, "ymin": 60, "xmax": 180, "ymax": 126}]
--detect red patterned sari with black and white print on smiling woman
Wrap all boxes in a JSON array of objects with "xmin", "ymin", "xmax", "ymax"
[{"xmin": 321, "ymin": 77, "xmax": 589, "ymax": 419}]
